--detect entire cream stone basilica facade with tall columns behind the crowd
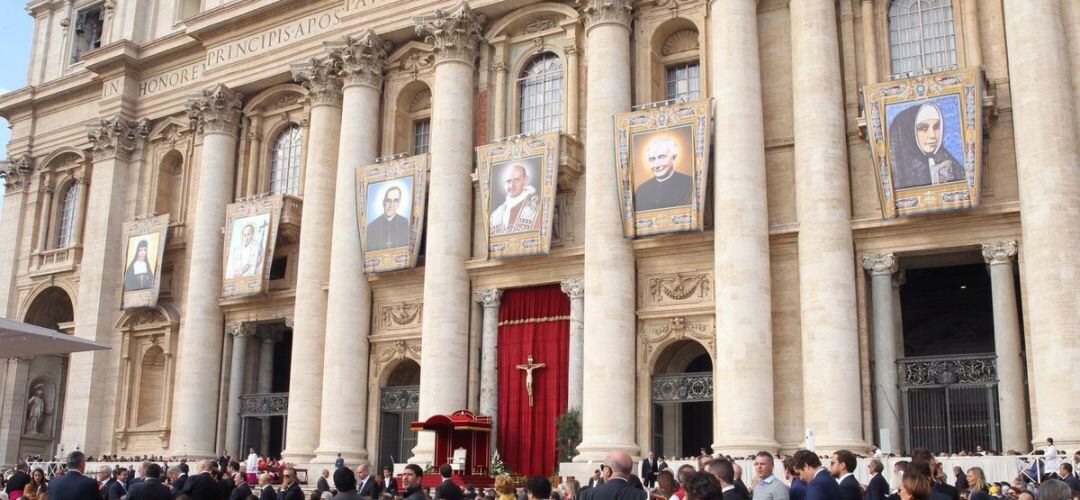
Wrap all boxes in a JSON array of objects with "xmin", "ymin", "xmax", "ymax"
[{"xmin": 0, "ymin": 0, "xmax": 1080, "ymax": 472}]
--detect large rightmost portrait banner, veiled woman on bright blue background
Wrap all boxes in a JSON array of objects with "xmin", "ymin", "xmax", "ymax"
[{"xmin": 863, "ymin": 68, "xmax": 983, "ymax": 219}]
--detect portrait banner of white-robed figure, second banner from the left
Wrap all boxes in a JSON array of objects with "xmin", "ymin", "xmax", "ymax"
[{"xmin": 221, "ymin": 194, "xmax": 283, "ymax": 298}]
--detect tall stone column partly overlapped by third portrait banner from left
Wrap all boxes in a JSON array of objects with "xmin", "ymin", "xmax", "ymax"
[{"xmin": 313, "ymin": 29, "xmax": 390, "ymax": 463}]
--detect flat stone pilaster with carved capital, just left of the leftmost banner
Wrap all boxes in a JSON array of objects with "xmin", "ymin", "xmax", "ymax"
[{"xmin": 60, "ymin": 116, "xmax": 149, "ymax": 455}]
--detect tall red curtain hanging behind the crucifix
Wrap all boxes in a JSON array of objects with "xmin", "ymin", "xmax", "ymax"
[{"xmin": 497, "ymin": 285, "xmax": 570, "ymax": 477}]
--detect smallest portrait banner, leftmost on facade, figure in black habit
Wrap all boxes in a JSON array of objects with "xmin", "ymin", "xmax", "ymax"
[{"xmin": 122, "ymin": 214, "xmax": 168, "ymax": 309}]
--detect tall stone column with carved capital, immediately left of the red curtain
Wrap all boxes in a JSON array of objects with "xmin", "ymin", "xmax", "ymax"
[{"xmin": 410, "ymin": 1, "xmax": 484, "ymax": 462}]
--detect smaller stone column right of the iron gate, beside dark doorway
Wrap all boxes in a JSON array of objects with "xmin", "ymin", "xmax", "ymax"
[{"xmin": 983, "ymin": 241, "xmax": 1028, "ymax": 450}]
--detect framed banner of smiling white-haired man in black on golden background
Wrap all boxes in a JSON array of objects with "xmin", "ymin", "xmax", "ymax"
[{"xmin": 615, "ymin": 99, "xmax": 712, "ymax": 238}]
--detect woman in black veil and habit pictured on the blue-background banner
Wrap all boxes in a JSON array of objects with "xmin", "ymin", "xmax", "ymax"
[{"xmin": 889, "ymin": 103, "xmax": 963, "ymax": 189}]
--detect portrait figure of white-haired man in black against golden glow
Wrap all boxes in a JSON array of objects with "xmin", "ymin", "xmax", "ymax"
[{"xmin": 634, "ymin": 137, "xmax": 693, "ymax": 212}]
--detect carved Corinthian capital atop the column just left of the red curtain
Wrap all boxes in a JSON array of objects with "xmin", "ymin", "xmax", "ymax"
[{"xmin": 413, "ymin": 1, "xmax": 486, "ymax": 65}]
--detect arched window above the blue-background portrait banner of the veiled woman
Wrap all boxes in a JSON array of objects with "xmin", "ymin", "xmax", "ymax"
[{"xmin": 889, "ymin": 0, "xmax": 956, "ymax": 76}]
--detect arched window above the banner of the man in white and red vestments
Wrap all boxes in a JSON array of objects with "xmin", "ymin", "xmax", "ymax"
[{"xmin": 517, "ymin": 52, "xmax": 563, "ymax": 134}]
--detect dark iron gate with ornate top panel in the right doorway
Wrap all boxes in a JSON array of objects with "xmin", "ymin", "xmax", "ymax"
[{"xmin": 896, "ymin": 354, "xmax": 1001, "ymax": 452}]
